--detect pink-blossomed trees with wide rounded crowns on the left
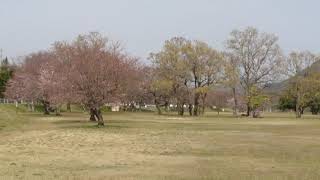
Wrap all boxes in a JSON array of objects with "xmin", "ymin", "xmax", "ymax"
[{"xmin": 6, "ymin": 33, "xmax": 141, "ymax": 126}]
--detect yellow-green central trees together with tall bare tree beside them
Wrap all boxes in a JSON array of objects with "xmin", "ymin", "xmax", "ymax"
[{"xmin": 150, "ymin": 28, "xmax": 284, "ymax": 117}]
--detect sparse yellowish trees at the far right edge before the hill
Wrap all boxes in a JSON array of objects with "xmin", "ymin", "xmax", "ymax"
[{"xmin": 279, "ymin": 52, "xmax": 320, "ymax": 118}]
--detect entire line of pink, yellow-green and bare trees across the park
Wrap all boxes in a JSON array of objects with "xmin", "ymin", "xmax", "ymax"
[{"xmin": 6, "ymin": 27, "xmax": 320, "ymax": 125}]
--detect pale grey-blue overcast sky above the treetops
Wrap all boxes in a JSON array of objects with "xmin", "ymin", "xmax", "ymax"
[{"xmin": 0, "ymin": 0, "xmax": 320, "ymax": 59}]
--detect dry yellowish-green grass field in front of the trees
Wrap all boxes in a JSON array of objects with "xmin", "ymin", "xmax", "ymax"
[{"xmin": 0, "ymin": 106, "xmax": 320, "ymax": 180}]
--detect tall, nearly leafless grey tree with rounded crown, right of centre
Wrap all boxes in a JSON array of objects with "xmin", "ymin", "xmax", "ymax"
[{"xmin": 227, "ymin": 27, "xmax": 282, "ymax": 116}]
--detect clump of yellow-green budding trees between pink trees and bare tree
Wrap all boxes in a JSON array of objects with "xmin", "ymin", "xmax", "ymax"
[{"xmin": 150, "ymin": 38, "xmax": 223, "ymax": 116}]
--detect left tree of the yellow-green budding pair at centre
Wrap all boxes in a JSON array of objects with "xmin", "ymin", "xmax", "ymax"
[{"xmin": 150, "ymin": 37, "xmax": 190, "ymax": 115}]
